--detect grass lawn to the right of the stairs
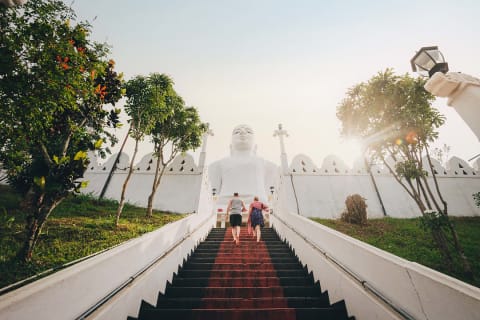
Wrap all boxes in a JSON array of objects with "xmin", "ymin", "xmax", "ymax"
[{"xmin": 312, "ymin": 217, "xmax": 480, "ymax": 287}]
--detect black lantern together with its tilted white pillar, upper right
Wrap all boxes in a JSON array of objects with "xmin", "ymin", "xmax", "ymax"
[{"xmin": 410, "ymin": 47, "xmax": 480, "ymax": 140}]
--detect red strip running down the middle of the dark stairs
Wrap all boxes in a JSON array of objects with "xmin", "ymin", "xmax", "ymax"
[{"xmin": 202, "ymin": 228, "xmax": 295, "ymax": 320}]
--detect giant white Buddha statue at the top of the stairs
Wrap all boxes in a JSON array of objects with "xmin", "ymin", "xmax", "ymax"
[{"xmin": 208, "ymin": 124, "xmax": 278, "ymax": 204}]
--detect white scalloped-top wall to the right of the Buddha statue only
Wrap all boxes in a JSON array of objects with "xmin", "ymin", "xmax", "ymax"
[{"xmin": 283, "ymin": 155, "xmax": 480, "ymax": 219}]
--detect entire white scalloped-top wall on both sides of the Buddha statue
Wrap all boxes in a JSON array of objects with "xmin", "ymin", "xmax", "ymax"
[{"xmin": 1, "ymin": 154, "xmax": 480, "ymax": 219}]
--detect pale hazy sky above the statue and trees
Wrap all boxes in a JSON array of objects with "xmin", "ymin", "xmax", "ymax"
[{"xmin": 65, "ymin": 0, "xmax": 480, "ymax": 166}]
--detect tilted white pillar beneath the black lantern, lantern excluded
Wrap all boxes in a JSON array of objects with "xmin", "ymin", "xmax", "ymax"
[{"xmin": 425, "ymin": 72, "xmax": 480, "ymax": 140}]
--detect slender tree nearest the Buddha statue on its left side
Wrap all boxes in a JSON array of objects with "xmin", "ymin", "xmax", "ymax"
[{"xmin": 147, "ymin": 89, "xmax": 207, "ymax": 217}]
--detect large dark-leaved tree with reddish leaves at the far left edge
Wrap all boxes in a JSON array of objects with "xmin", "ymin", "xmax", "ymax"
[{"xmin": 0, "ymin": 0, "xmax": 121, "ymax": 261}]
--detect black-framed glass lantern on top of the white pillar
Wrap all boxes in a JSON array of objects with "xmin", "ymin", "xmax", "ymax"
[{"xmin": 410, "ymin": 47, "xmax": 448, "ymax": 77}]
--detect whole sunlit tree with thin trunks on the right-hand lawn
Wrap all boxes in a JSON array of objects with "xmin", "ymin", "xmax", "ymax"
[{"xmin": 337, "ymin": 69, "xmax": 473, "ymax": 277}]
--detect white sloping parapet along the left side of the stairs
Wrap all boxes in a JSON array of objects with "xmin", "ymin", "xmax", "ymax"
[{"xmin": 0, "ymin": 172, "xmax": 216, "ymax": 320}]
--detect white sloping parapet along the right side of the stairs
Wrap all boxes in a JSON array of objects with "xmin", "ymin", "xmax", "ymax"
[{"xmin": 271, "ymin": 176, "xmax": 480, "ymax": 320}]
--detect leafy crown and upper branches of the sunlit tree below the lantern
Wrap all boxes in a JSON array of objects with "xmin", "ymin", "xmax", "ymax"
[{"xmin": 337, "ymin": 69, "xmax": 446, "ymax": 212}]
